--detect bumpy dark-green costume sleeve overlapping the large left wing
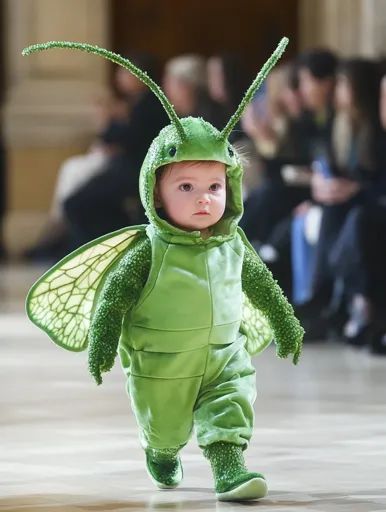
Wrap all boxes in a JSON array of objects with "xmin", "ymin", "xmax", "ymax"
[{"xmin": 88, "ymin": 237, "xmax": 151, "ymax": 384}]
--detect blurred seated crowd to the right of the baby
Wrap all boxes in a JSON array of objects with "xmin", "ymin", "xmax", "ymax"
[{"xmin": 238, "ymin": 50, "xmax": 386, "ymax": 354}]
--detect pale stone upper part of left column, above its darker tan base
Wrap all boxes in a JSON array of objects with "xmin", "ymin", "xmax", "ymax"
[{"xmin": 4, "ymin": 0, "xmax": 108, "ymax": 147}]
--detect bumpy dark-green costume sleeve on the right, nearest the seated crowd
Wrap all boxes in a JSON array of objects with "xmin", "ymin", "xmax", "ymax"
[{"xmin": 242, "ymin": 247, "xmax": 304, "ymax": 364}]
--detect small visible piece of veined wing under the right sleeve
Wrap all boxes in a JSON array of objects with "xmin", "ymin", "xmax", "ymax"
[{"xmin": 240, "ymin": 293, "xmax": 273, "ymax": 355}]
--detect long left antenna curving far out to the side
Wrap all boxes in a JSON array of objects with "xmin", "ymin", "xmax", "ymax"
[{"xmin": 22, "ymin": 41, "xmax": 186, "ymax": 140}]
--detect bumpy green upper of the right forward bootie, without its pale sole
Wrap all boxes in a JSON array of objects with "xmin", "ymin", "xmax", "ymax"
[{"xmin": 204, "ymin": 442, "xmax": 264, "ymax": 494}]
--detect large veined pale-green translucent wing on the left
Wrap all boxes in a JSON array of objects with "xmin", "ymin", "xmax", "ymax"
[{"xmin": 26, "ymin": 226, "xmax": 146, "ymax": 352}]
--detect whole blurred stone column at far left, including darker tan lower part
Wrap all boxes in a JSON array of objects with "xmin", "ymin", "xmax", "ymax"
[{"xmin": 2, "ymin": 0, "xmax": 109, "ymax": 253}]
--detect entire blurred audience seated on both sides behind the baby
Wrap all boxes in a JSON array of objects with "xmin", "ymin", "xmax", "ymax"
[{"xmin": 0, "ymin": 49, "xmax": 386, "ymax": 354}]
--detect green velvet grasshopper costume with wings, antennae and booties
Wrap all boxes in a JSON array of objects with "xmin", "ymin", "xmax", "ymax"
[{"xmin": 24, "ymin": 39, "xmax": 303, "ymax": 500}]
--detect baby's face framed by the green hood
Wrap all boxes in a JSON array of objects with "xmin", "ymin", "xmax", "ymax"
[{"xmin": 156, "ymin": 161, "xmax": 226, "ymax": 231}]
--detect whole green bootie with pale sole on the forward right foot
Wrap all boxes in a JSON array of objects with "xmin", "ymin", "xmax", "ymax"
[{"xmin": 204, "ymin": 442, "xmax": 268, "ymax": 501}]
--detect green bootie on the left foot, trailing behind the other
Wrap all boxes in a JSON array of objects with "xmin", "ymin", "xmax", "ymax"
[{"xmin": 146, "ymin": 448, "xmax": 183, "ymax": 489}]
